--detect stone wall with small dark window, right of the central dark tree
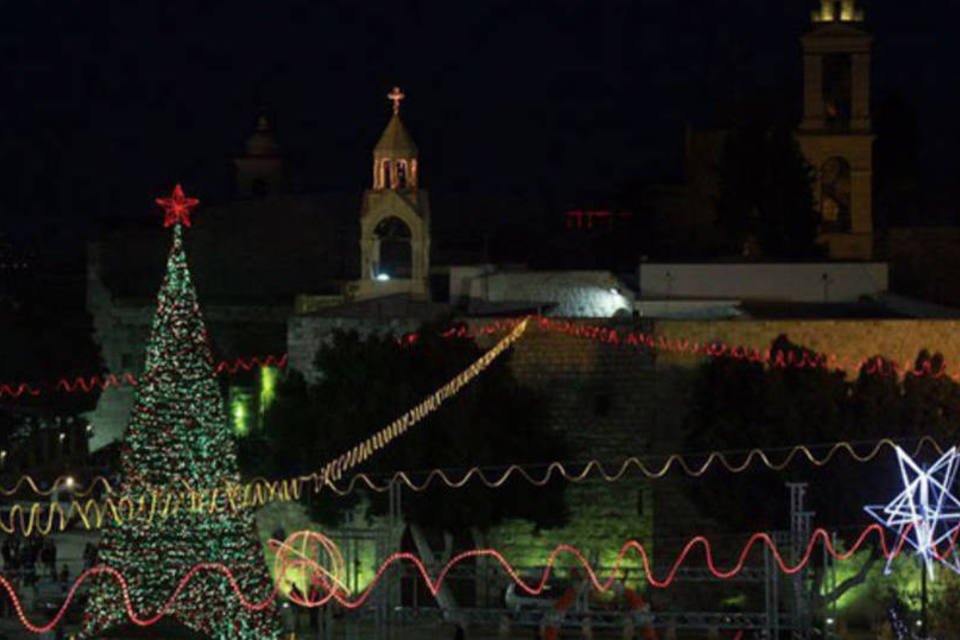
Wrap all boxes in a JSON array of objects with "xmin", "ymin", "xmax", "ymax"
[{"xmin": 474, "ymin": 326, "xmax": 656, "ymax": 566}]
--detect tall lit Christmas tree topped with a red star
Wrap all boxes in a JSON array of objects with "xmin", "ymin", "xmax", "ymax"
[{"xmin": 83, "ymin": 185, "xmax": 280, "ymax": 640}]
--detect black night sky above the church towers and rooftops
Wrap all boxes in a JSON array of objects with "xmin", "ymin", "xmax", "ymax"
[{"xmin": 0, "ymin": 0, "xmax": 960, "ymax": 250}]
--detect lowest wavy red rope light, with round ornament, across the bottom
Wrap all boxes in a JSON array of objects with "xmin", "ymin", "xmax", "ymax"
[{"xmin": 0, "ymin": 524, "xmax": 936, "ymax": 633}]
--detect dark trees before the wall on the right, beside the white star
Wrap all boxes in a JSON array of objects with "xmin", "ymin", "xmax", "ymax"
[{"xmin": 686, "ymin": 336, "xmax": 960, "ymax": 620}]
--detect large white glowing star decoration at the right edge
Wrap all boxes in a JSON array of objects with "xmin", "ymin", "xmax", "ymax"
[{"xmin": 864, "ymin": 447, "xmax": 960, "ymax": 578}]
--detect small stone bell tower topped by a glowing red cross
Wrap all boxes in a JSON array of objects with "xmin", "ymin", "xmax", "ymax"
[{"xmin": 356, "ymin": 87, "xmax": 430, "ymax": 298}]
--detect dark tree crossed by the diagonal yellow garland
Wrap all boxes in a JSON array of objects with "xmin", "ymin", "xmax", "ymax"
[{"xmin": 265, "ymin": 325, "xmax": 566, "ymax": 531}]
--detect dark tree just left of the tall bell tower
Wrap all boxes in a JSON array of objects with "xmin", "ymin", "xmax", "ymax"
[{"xmin": 717, "ymin": 120, "xmax": 821, "ymax": 259}]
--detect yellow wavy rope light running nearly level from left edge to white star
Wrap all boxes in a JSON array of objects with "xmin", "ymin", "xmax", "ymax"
[{"xmin": 0, "ymin": 436, "xmax": 944, "ymax": 536}]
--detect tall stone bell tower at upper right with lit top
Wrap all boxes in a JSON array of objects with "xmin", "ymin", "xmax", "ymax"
[{"xmin": 797, "ymin": 0, "xmax": 874, "ymax": 260}]
